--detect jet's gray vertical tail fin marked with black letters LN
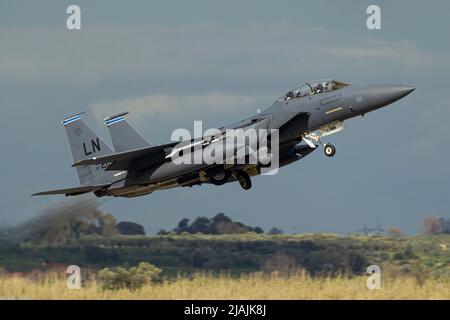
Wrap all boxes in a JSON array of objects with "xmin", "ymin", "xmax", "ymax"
[{"xmin": 62, "ymin": 113, "xmax": 115, "ymax": 186}]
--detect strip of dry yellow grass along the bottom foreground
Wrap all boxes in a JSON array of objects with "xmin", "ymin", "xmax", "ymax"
[{"xmin": 0, "ymin": 273, "xmax": 450, "ymax": 300}]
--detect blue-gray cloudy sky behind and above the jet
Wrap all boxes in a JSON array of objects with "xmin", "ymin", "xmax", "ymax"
[{"xmin": 0, "ymin": 0, "xmax": 450, "ymax": 234}]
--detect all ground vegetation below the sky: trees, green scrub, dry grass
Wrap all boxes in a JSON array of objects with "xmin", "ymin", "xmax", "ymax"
[{"xmin": 0, "ymin": 211, "xmax": 450, "ymax": 299}]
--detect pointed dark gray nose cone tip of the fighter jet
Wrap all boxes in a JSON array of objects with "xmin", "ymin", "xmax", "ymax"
[{"xmin": 367, "ymin": 85, "xmax": 416, "ymax": 107}]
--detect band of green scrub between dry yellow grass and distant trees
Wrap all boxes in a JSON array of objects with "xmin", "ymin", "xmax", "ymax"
[{"xmin": 0, "ymin": 233, "xmax": 450, "ymax": 277}]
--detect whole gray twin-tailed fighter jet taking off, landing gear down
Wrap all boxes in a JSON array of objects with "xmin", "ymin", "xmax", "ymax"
[{"xmin": 33, "ymin": 79, "xmax": 415, "ymax": 197}]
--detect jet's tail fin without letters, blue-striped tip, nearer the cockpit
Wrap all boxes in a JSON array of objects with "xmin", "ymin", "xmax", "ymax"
[{"xmin": 105, "ymin": 112, "xmax": 151, "ymax": 152}]
